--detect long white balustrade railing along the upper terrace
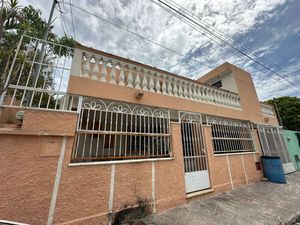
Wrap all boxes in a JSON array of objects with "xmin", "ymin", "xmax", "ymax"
[{"xmin": 75, "ymin": 50, "xmax": 241, "ymax": 110}]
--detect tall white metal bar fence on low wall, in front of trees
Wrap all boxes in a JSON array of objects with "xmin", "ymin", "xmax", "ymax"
[{"xmin": 0, "ymin": 35, "xmax": 78, "ymax": 111}]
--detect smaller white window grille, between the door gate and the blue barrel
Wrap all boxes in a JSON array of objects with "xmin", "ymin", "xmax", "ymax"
[{"xmin": 206, "ymin": 116, "xmax": 255, "ymax": 154}]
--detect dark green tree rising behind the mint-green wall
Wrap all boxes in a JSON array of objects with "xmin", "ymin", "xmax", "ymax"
[{"xmin": 266, "ymin": 96, "xmax": 300, "ymax": 131}]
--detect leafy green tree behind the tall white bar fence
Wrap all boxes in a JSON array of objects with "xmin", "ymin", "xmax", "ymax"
[{"xmin": 0, "ymin": 0, "xmax": 75, "ymax": 94}]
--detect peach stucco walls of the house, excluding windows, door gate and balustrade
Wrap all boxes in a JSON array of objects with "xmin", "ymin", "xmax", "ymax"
[{"xmin": 0, "ymin": 44, "xmax": 278, "ymax": 225}]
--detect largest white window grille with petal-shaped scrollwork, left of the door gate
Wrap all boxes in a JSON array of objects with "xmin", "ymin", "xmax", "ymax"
[{"xmin": 71, "ymin": 98, "xmax": 171, "ymax": 162}]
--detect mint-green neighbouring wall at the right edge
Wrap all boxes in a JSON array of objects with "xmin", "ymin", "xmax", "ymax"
[{"xmin": 283, "ymin": 130, "xmax": 300, "ymax": 170}]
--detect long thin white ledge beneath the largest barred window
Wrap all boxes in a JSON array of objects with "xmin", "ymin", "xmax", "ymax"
[{"xmin": 69, "ymin": 157, "xmax": 175, "ymax": 167}]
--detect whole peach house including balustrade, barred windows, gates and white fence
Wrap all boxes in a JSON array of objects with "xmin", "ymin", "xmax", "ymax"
[{"xmin": 0, "ymin": 36, "xmax": 293, "ymax": 224}]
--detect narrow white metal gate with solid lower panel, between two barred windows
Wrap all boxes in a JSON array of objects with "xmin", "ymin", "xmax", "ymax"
[{"xmin": 179, "ymin": 112, "xmax": 210, "ymax": 193}]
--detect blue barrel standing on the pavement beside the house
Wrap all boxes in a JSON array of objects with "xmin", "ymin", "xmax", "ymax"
[{"xmin": 261, "ymin": 156, "xmax": 286, "ymax": 183}]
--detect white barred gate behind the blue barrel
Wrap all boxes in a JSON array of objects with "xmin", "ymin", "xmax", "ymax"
[{"xmin": 257, "ymin": 125, "xmax": 291, "ymax": 163}]
